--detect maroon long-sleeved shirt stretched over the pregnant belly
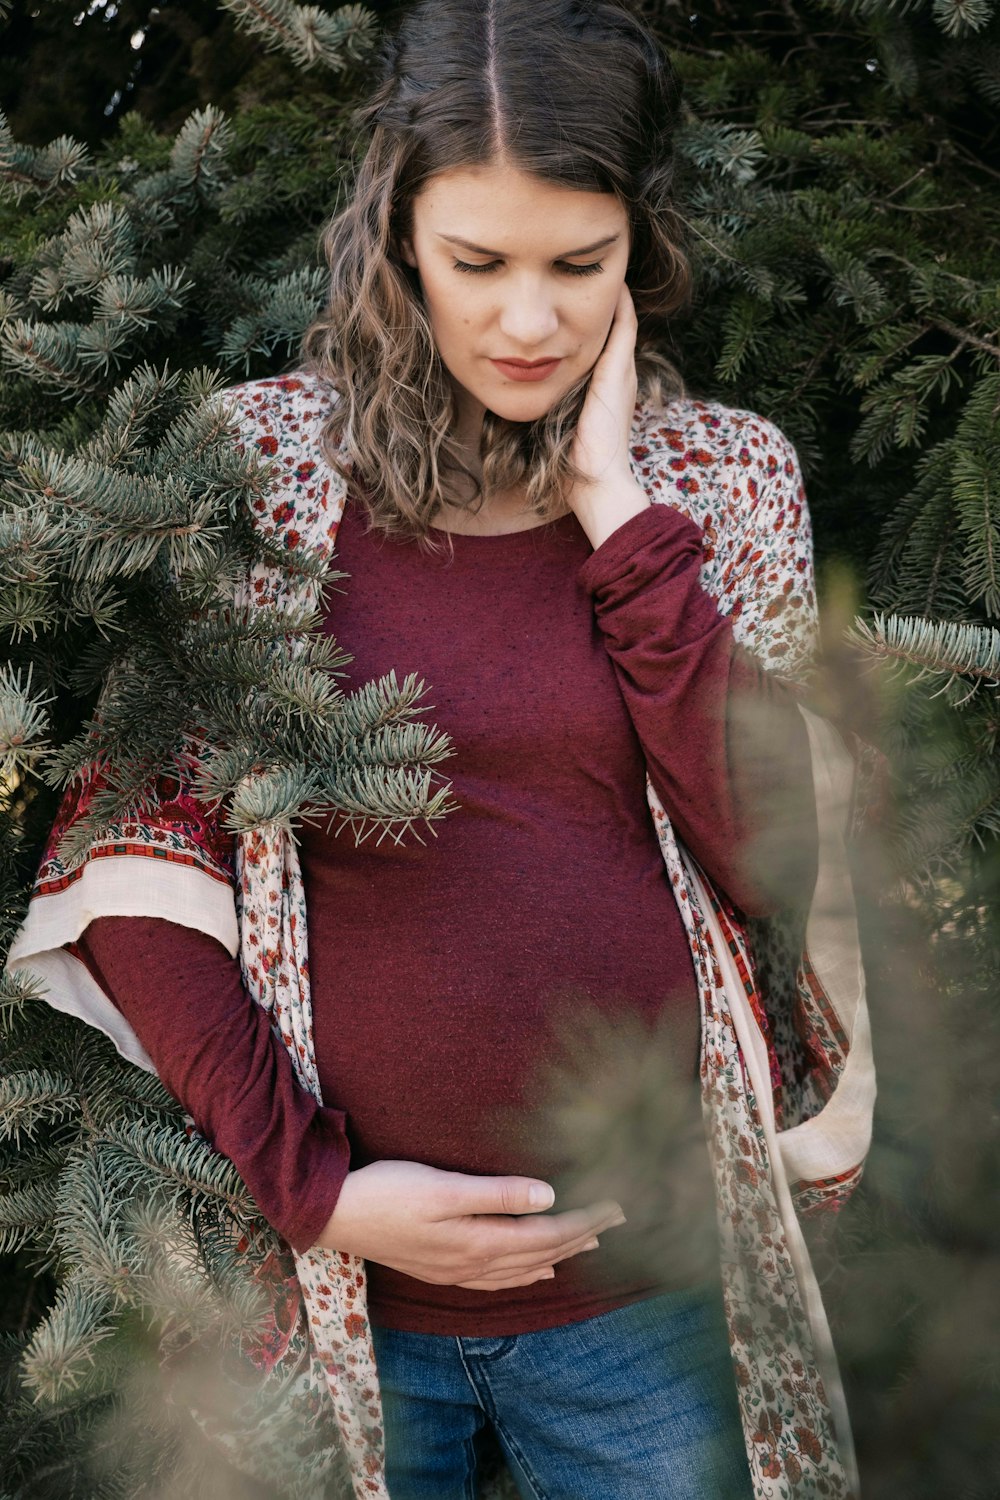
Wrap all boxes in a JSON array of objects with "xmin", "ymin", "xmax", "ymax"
[{"xmin": 79, "ymin": 503, "xmax": 816, "ymax": 1335}]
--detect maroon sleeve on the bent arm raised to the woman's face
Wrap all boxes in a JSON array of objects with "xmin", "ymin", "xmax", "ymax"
[{"xmin": 579, "ymin": 504, "xmax": 817, "ymax": 915}]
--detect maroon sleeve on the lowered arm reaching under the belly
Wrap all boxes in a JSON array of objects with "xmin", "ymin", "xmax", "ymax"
[{"xmin": 73, "ymin": 917, "xmax": 349, "ymax": 1251}]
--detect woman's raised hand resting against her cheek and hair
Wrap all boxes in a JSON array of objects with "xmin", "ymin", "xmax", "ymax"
[{"xmin": 567, "ymin": 282, "xmax": 649, "ymax": 548}]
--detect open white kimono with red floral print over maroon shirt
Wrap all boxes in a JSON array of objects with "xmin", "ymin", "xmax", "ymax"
[{"xmin": 9, "ymin": 375, "xmax": 874, "ymax": 1500}]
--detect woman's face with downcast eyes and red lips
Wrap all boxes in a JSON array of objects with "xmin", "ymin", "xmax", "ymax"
[{"xmin": 400, "ymin": 165, "xmax": 630, "ymax": 449}]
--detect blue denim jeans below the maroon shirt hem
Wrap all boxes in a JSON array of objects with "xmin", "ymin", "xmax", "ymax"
[{"xmin": 372, "ymin": 1284, "xmax": 753, "ymax": 1500}]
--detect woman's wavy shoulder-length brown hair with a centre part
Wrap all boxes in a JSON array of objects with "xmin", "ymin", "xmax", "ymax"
[{"xmin": 298, "ymin": 0, "xmax": 691, "ymax": 551}]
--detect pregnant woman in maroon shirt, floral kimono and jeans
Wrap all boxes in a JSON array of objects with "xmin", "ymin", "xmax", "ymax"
[{"xmin": 7, "ymin": 0, "xmax": 865, "ymax": 1500}]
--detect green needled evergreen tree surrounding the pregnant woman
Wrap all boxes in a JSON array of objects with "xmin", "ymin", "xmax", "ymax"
[{"xmin": 0, "ymin": 0, "xmax": 1000, "ymax": 1500}]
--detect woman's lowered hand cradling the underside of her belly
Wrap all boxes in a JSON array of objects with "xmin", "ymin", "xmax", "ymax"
[{"xmin": 318, "ymin": 1161, "xmax": 625, "ymax": 1292}]
